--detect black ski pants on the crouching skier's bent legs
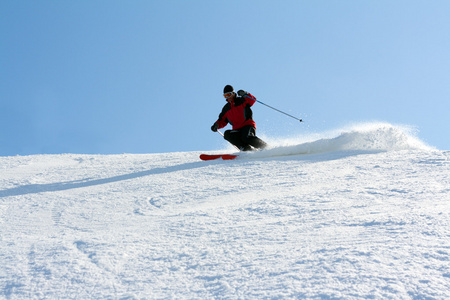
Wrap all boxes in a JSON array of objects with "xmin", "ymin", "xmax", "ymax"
[{"xmin": 224, "ymin": 125, "xmax": 267, "ymax": 151}]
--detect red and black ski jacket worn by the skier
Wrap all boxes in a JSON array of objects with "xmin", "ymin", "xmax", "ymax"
[{"xmin": 216, "ymin": 93, "xmax": 256, "ymax": 130}]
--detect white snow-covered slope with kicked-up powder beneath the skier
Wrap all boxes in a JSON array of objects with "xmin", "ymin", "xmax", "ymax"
[{"xmin": 0, "ymin": 124, "xmax": 450, "ymax": 299}]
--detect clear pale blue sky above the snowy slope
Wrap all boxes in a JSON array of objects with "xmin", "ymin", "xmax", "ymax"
[{"xmin": 0, "ymin": 0, "xmax": 450, "ymax": 156}]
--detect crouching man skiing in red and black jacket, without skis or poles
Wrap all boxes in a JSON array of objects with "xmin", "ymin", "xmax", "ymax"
[{"xmin": 211, "ymin": 85, "xmax": 267, "ymax": 151}]
